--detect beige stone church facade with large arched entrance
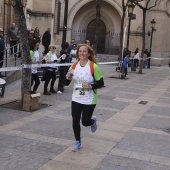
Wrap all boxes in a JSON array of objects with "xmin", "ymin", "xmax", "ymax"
[{"xmin": 0, "ymin": 0, "xmax": 170, "ymax": 65}]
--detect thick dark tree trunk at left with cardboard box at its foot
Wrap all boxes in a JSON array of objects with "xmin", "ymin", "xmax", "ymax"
[{"xmin": 13, "ymin": 0, "xmax": 31, "ymax": 105}]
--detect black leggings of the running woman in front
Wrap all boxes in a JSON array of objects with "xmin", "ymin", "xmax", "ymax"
[{"xmin": 71, "ymin": 101, "xmax": 96, "ymax": 142}]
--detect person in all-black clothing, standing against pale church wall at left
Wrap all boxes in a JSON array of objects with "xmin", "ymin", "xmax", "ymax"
[{"xmin": 42, "ymin": 28, "xmax": 51, "ymax": 55}]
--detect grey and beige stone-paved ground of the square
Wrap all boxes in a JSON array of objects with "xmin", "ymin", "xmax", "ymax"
[{"xmin": 0, "ymin": 65, "xmax": 170, "ymax": 170}]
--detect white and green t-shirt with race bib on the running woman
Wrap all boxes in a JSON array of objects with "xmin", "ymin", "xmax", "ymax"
[{"xmin": 69, "ymin": 60, "xmax": 103, "ymax": 105}]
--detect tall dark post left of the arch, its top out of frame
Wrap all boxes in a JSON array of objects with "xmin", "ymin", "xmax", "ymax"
[{"xmin": 60, "ymin": 0, "xmax": 68, "ymax": 54}]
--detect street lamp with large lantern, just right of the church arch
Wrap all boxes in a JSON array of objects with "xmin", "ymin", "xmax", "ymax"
[{"xmin": 126, "ymin": 2, "xmax": 135, "ymax": 50}]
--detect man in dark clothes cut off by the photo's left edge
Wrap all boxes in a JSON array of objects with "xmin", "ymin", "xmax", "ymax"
[{"xmin": 0, "ymin": 28, "xmax": 5, "ymax": 77}]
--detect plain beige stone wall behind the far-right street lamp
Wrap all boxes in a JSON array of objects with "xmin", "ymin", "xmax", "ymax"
[{"xmin": 146, "ymin": 0, "xmax": 170, "ymax": 62}]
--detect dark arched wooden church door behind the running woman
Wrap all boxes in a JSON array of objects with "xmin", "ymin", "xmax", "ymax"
[{"xmin": 86, "ymin": 19, "xmax": 106, "ymax": 53}]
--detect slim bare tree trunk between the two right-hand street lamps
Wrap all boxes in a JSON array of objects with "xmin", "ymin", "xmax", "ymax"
[{"xmin": 139, "ymin": 9, "xmax": 147, "ymax": 74}]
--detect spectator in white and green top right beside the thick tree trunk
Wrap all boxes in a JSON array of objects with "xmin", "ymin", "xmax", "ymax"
[{"xmin": 30, "ymin": 40, "xmax": 42, "ymax": 93}]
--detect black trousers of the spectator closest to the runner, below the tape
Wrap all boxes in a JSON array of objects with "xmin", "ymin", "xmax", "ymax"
[{"xmin": 58, "ymin": 67, "xmax": 66, "ymax": 92}]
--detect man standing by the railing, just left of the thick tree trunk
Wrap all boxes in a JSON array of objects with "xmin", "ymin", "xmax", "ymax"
[{"xmin": 8, "ymin": 23, "xmax": 19, "ymax": 57}]
